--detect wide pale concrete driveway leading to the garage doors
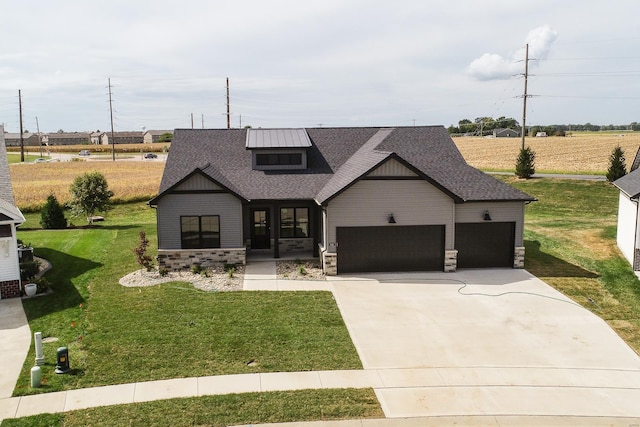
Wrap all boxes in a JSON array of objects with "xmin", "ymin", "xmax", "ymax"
[{"xmin": 333, "ymin": 269, "xmax": 640, "ymax": 418}]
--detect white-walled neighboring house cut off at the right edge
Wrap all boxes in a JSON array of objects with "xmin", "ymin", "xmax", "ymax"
[{"xmin": 613, "ymin": 149, "xmax": 640, "ymax": 271}]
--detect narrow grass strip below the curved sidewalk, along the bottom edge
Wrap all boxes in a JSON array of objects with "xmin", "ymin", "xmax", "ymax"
[{"xmin": 1, "ymin": 389, "xmax": 384, "ymax": 427}]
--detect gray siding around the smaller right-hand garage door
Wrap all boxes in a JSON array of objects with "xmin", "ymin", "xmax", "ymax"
[{"xmin": 455, "ymin": 202, "xmax": 524, "ymax": 246}]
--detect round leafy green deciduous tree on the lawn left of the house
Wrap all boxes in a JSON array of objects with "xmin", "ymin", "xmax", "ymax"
[{"xmin": 68, "ymin": 172, "xmax": 113, "ymax": 224}]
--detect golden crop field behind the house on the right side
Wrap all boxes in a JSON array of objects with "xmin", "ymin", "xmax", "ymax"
[{"xmin": 453, "ymin": 132, "xmax": 640, "ymax": 175}]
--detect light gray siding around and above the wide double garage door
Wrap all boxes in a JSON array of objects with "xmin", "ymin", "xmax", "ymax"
[{"xmin": 326, "ymin": 179, "xmax": 454, "ymax": 252}]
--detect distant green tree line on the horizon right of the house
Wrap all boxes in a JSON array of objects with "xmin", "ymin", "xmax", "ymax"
[{"xmin": 447, "ymin": 116, "xmax": 640, "ymax": 136}]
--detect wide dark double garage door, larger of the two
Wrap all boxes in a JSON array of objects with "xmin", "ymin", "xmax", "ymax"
[{"xmin": 336, "ymin": 225, "xmax": 445, "ymax": 273}]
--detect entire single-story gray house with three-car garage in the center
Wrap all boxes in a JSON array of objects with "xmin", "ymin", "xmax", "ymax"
[{"xmin": 149, "ymin": 126, "xmax": 535, "ymax": 275}]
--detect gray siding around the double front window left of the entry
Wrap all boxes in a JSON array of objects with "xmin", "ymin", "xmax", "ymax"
[{"xmin": 158, "ymin": 193, "xmax": 244, "ymax": 249}]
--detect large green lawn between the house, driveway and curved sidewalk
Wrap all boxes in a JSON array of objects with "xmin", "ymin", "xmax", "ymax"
[{"xmin": 14, "ymin": 204, "xmax": 362, "ymax": 395}]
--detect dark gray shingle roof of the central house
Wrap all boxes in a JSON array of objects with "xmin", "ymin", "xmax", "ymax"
[{"xmin": 151, "ymin": 126, "xmax": 535, "ymax": 204}]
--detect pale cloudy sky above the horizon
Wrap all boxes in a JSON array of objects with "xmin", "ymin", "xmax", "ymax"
[{"xmin": 0, "ymin": 0, "xmax": 640, "ymax": 132}]
